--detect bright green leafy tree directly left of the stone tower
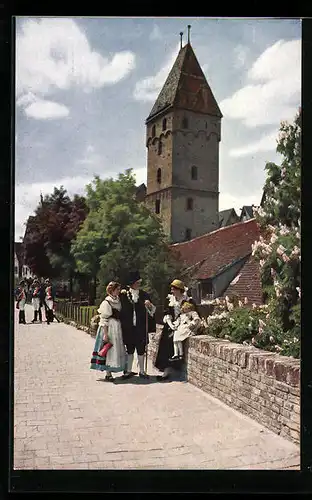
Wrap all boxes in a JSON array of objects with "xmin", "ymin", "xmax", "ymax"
[{"xmin": 72, "ymin": 170, "xmax": 184, "ymax": 301}]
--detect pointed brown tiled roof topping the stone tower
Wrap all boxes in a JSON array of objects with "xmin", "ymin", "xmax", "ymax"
[{"xmin": 146, "ymin": 43, "xmax": 222, "ymax": 122}]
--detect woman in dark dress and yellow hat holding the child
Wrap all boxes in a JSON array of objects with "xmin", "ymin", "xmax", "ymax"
[{"xmin": 155, "ymin": 279, "xmax": 193, "ymax": 382}]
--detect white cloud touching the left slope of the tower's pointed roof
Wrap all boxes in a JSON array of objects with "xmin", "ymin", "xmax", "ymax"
[{"xmin": 133, "ymin": 45, "xmax": 180, "ymax": 101}]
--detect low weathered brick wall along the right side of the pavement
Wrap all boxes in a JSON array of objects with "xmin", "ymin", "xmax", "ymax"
[{"xmin": 149, "ymin": 326, "xmax": 300, "ymax": 443}]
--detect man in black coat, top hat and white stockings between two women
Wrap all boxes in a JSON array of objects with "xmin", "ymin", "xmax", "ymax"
[{"xmin": 120, "ymin": 271, "xmax": 156, "ymax": 378}]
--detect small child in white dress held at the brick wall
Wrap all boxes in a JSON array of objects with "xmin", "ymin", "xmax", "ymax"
[{"xmin": 171, "ymin": 301, "xmax": 201, "ymax": 361}]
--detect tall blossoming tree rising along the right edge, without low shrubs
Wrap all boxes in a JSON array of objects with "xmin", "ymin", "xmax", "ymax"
[{"xmin": 253, "ymin": 110, "xmax": 301, "ymax": 355}]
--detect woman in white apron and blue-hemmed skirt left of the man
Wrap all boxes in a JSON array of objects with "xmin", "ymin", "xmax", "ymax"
[{"xmin": 90, "ymin": 281, "xmax": 126, "ymax": 382}]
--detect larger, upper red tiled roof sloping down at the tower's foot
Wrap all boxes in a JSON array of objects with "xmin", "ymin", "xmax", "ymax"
[{"xmin": 170, "ymin": 219, "xmax": 260, "ymax": 280}]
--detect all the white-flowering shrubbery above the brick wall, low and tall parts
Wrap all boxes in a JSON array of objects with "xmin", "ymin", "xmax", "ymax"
[{"xmin": 202, "ymin": 110, "xmax": 301, "ymax": 358}]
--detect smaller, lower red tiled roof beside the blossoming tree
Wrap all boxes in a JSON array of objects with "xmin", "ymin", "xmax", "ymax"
[{"xmin": 222, "ymin": 255, "xmax": 263, "ymax": 305}]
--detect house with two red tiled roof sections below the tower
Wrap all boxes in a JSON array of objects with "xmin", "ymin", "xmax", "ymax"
[{"xmin": 170, "ymin": 219, "xmax": 262, "ymax": 304}]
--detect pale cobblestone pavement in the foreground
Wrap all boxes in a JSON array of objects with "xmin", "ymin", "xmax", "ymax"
[{"xmin": 14, "ymin": 306, "xmax": 300, "ymax": 469}]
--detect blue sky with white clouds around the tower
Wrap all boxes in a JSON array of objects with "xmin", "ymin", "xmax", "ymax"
[{"xmin": 15, "ymin": 17, "xmax": 301, "ymax": 241}]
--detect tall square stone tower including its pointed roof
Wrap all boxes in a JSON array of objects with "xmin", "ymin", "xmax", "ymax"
[{"xmin": 145, "ymin": 34, "xmax": 222, "ymax": 243}]
